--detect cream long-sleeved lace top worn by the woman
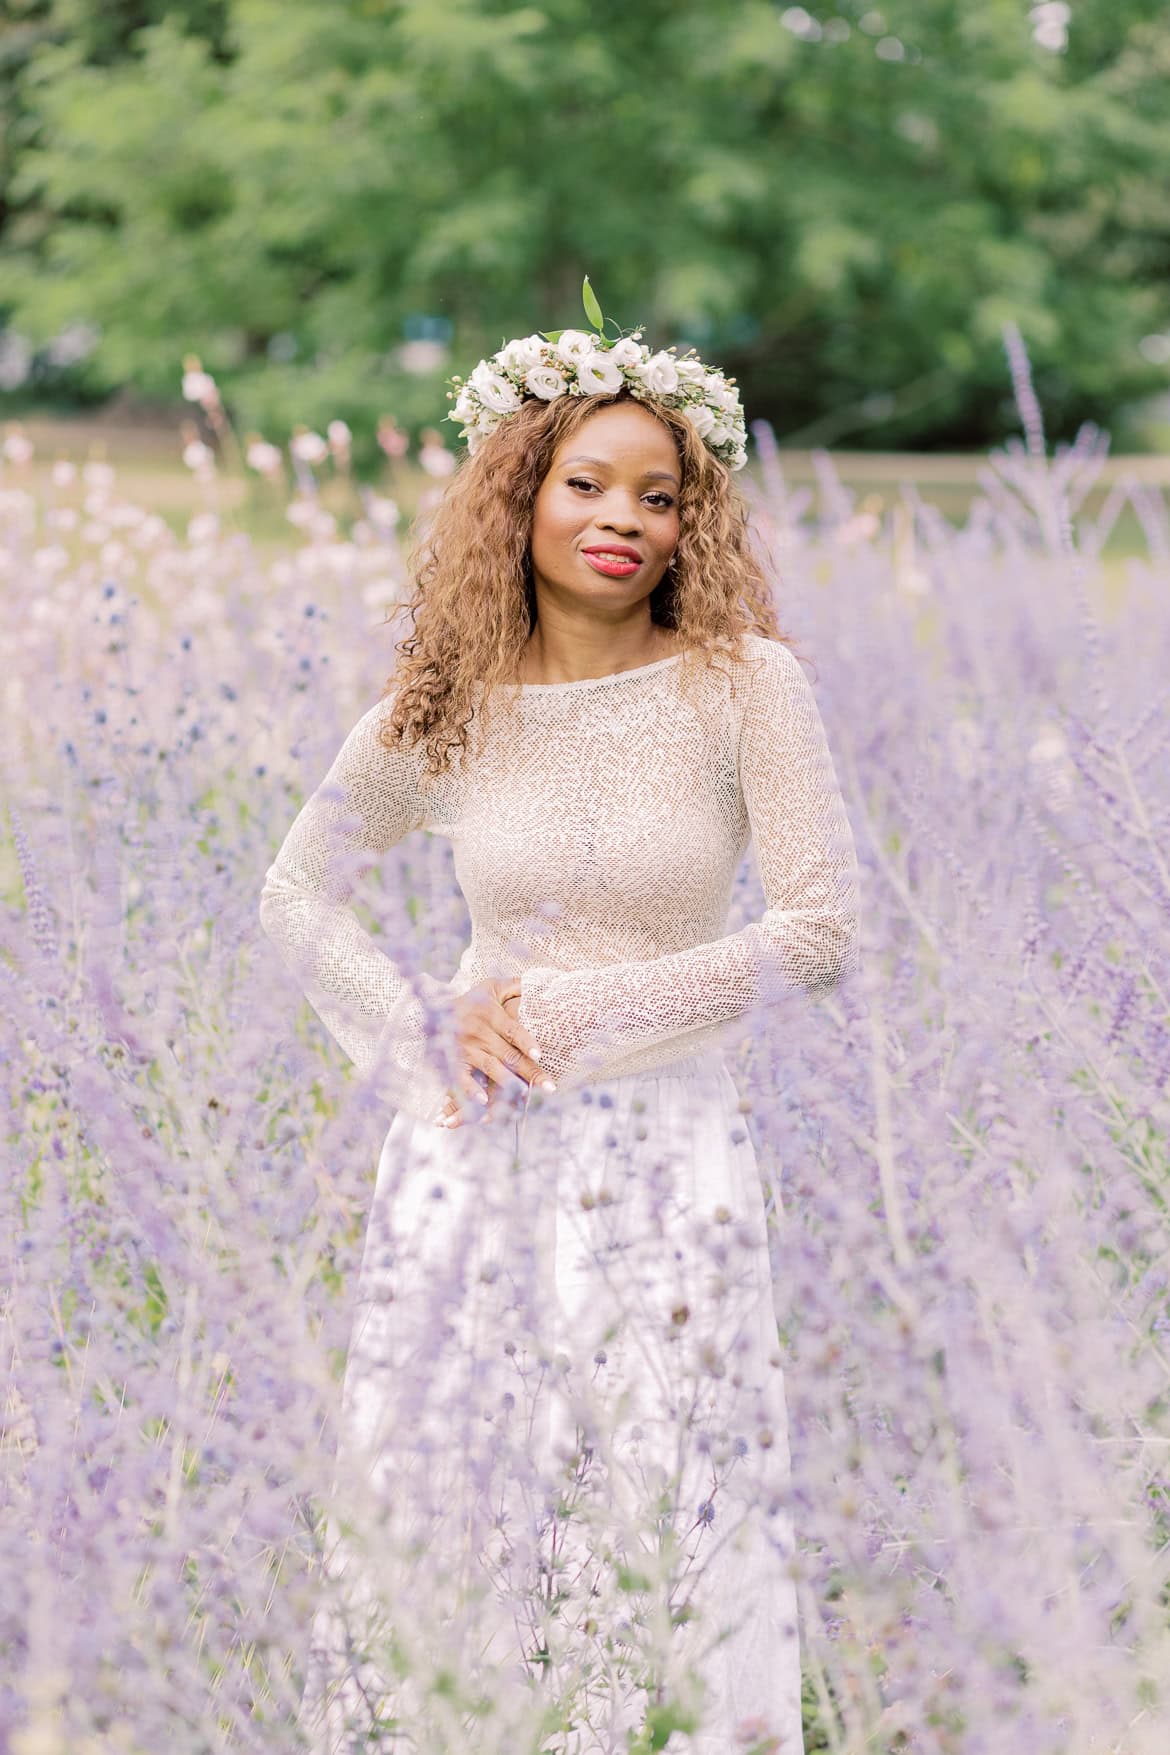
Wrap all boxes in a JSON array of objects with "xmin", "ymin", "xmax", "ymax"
[{"xmin": 261, "ymin": 635, "xmax": 858, "ymax": 1121}]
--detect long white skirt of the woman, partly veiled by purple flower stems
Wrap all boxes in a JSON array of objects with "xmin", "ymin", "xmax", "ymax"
[{"xmin": 300, "ymin": 1053, "xmax": 803, "ymax": 1755}]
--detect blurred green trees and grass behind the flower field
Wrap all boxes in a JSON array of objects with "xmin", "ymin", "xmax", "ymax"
[{"xmin": 0, "ymin": 0, "xmax": 1170, "ymax": 516}]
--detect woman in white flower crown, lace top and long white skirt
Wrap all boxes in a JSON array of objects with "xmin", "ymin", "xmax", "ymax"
[{"xmin": 261, "ymin": 319, "xmax": 856, "ymax": 1755}]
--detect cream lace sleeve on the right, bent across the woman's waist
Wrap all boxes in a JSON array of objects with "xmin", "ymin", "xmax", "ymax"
[{"xmin": 519, "ymin": 641, "xmax": 858, "ymax": 1078}]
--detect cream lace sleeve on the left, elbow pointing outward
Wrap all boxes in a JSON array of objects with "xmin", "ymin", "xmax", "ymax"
[{"xmin": 260, "ymin": 702, "xmax": 447, "ymax": 1121}]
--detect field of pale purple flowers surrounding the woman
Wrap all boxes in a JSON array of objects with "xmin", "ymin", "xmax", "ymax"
[{"xmin": 0, "ymin": 347, "xmax": 1170, "ymax": 1755}]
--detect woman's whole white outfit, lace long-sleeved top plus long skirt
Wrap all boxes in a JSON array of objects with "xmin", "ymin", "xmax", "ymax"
[{"xmin": 261, "ymin": 635, "xmax": 858, "ymax": 1755}]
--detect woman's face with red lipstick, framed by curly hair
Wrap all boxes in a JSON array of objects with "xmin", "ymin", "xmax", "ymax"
[{"xmin": 531, "ymin": 402, "xmax": 681, "ymax": 609}]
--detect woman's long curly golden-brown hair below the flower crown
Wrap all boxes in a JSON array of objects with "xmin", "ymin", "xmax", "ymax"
[{"xmin": 379, "ymin": 388, "xmax": 784, "ymax": 776}]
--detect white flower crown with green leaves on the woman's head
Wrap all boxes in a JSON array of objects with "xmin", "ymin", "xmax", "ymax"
[{"xmin": 447, "ymin": 276, "xmax": 747, "ymax": 469}]
